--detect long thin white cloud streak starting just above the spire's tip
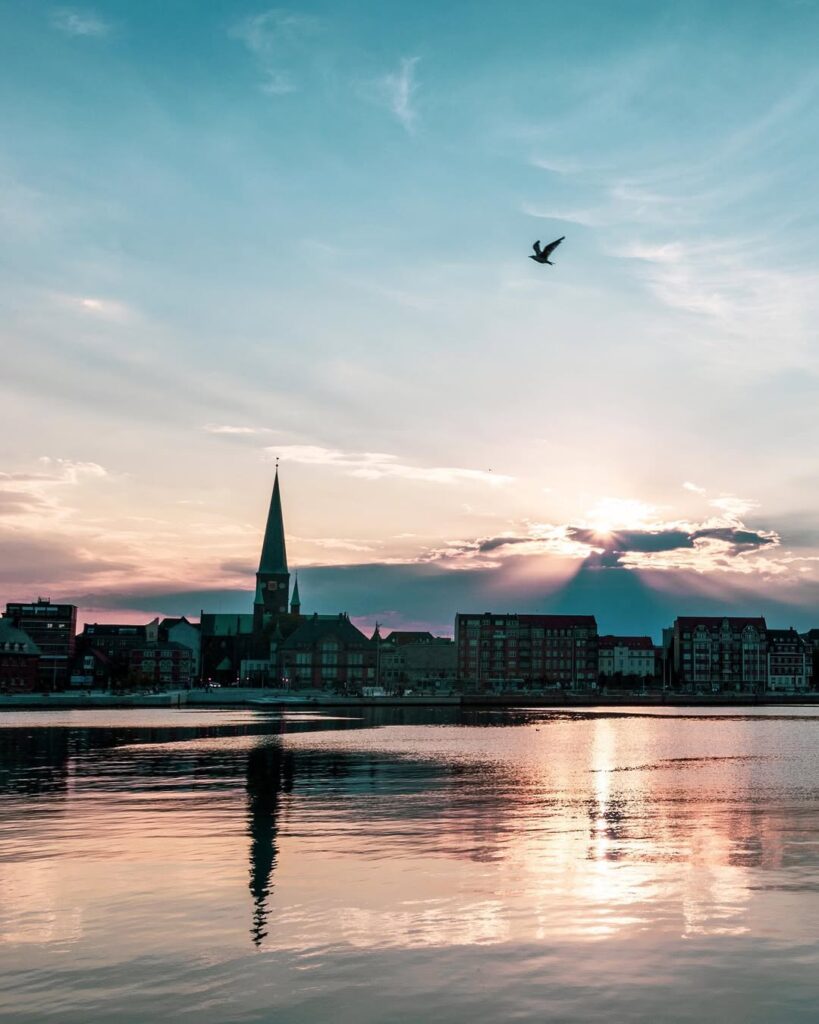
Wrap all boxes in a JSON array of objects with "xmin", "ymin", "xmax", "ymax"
[{"xmin": 265, "ymin": 444, "xmax": 513, "ymax": 486}]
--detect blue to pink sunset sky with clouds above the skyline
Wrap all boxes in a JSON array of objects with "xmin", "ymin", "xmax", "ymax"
[{"xmin": 0, "ymin": 0, "xmax": 819, "ymax": 636}]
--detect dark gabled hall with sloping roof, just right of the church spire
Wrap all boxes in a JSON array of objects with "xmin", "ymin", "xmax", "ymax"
[{"xmin": 277, "ymin": 612, "xmax": 378, "ymax": 693}]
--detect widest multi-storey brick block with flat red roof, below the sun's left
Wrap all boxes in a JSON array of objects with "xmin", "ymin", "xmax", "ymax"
[{"xmin": 455, "ymin": 611, "xmax": 598, "ymax": 690}]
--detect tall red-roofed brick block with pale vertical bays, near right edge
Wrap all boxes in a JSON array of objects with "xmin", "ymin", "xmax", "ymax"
[{"xmin": 671, "ymin": 615, "xmax": 768, "ymax": 692}]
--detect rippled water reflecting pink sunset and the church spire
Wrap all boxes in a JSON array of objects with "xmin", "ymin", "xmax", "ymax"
[{"xmin": 0, "ymin": 708, "xmax": 819, "ymax": 1024}]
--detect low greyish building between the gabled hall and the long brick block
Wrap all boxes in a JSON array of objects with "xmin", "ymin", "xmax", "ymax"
[{"xmin": 373, "ymin": 630, "xmax": 458, "ymax": 692}]
